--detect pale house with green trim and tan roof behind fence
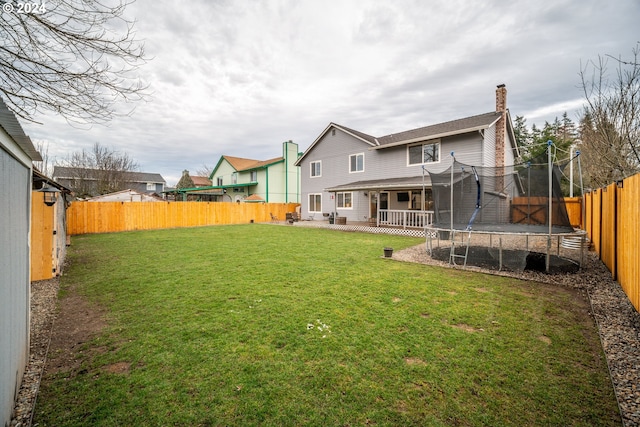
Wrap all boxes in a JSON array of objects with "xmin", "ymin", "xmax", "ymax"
[{"xmin": 170, "ymin": 141, "xmax": 300, "ymax": 203}]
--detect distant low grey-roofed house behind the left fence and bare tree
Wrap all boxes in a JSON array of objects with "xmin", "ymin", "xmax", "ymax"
[{"xmin": 53, "ymin": 166, "xmax": 166, "ymax": 198}]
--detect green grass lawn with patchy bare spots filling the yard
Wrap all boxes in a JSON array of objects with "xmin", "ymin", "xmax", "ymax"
[{"xmin": 34, "ymin": 224, "xmax": 620, "ymax": 426}]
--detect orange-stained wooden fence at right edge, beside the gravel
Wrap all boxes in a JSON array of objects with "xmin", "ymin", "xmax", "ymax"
[{"xmin": 584, "ymin": 174, "xmax": 640, "ymax": 311}]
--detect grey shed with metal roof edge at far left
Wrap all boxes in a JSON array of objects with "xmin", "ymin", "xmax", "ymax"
[{"xmin": 0, "ymin": 98, "xmax": 42, "ymax": 426}]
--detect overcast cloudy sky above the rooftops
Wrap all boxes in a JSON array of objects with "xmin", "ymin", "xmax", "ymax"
[{"xmin": 23, "ymin": 0, "xmax": 640, "ymax": 186}]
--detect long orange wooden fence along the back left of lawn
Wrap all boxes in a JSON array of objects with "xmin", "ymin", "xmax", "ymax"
[{"xmin": 67, "ymin": 202, "xmax": 299, "ymax": 235}]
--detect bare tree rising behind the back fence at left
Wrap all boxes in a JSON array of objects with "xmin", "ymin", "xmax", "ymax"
[{"xmin": 59, "ymin": 143, "xmax": 139, "ymax": 197}]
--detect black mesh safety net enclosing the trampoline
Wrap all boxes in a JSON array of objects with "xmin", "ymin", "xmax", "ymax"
[{"xmin": 429, "ymin": 158, "xmax": 573, "ymax": 233}]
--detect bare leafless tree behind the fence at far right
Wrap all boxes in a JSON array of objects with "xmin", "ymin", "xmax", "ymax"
[{"xmin": 580, "ymin": 43, "xmax": 640, "ymax": 187}]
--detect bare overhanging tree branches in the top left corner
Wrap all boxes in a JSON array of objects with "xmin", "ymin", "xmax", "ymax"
[{"xmin": 0, "ymin": 0, "xmax": 147, "ymax": 123}]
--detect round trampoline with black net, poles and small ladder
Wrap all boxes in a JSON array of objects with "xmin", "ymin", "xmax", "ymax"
[{"xmin": 425, "ymin": 141, "xmax": 587, "ymax": 273}]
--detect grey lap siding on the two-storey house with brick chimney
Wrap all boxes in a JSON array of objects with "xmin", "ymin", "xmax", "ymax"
[{"xmin": 300, "ymin": 128, "xmax": 482, "ymax": 221}]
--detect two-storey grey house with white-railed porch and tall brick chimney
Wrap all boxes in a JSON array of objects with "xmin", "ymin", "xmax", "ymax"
[{"xmin": 296, "ymin": 85, "xmax": 518, "ymax": 226}]
